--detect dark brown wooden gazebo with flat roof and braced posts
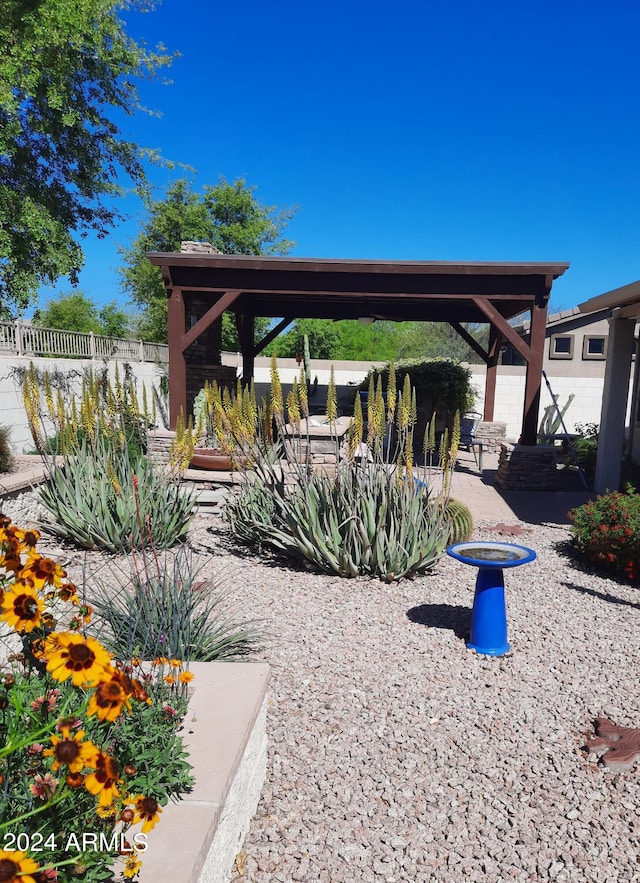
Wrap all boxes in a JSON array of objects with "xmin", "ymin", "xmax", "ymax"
[{"xmin": 147, "ymin": 249, "xmax": 569, "ymax": 445}]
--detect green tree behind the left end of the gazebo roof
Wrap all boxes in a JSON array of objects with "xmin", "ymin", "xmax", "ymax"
[{"xmin": 120, "ymin": 178, "xmax": 295, "ymax": 351}]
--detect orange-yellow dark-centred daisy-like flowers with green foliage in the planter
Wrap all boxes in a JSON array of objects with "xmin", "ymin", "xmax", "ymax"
[{"xmin": 0, "ymin": 516, "xmax": 192, "ymax": 883}]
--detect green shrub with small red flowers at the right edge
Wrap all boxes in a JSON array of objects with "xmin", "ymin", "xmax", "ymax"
[{"xmin": 569, "ymin": 485, "xmax": 640, "ymax": 583}]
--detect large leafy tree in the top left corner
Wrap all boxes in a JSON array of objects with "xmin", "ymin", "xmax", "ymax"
[{"xmin": 0, "ymin": 0, "xmax": 170, "ymax": 310}]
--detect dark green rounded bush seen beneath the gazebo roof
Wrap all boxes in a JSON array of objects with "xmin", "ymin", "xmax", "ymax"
[{"xmin": 360, "ymin": 359, "xmax": 475, "ymax": 419}]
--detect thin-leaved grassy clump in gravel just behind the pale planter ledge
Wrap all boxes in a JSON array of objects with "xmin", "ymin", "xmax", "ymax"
[{"xmin": 90, "ymin": 549, "xmax": 261, "ymax": 662}]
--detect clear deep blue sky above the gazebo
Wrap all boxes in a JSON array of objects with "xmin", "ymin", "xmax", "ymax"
[{"xmin": 41, "ymin": 0, "xmax": 640, "ymax": 316}]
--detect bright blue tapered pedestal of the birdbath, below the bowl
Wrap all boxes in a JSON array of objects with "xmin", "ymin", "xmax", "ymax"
[{"xmin": 467, "ymin": 567, "xmax": 511, "ymax": 656}]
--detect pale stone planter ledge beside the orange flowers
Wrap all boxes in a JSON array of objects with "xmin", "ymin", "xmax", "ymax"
[{"xmin": 140, "ymin": 662, "xmax": 270, "ymax": 883}]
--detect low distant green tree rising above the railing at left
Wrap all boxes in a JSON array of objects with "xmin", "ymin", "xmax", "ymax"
[{"xmin": 33, "ymin": 291, "xmax": 129, "ymax": 337}]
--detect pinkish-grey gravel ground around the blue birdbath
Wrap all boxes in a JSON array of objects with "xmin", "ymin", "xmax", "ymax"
[{"xmin": 1, "ymin": 499, "xmax": 640, "ymax": 883}]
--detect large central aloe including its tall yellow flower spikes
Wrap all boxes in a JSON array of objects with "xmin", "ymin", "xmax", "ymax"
[{"xmin": 226, "ymin": 369, "xmax": 459, "ymax": 582}]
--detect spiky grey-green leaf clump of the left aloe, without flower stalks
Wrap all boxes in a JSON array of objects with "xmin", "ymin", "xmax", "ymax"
[{"xmin": 40, "ymin": 436, "xmax": 196, "ymax": 552}]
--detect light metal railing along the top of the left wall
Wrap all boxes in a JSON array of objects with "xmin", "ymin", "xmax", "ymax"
[{"xmin": 0, "ymin": 320, "xmax": 169, "ymax": 363}]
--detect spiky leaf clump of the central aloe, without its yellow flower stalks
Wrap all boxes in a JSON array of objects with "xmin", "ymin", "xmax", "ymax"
[{"xmin": 226, "ymin": 461, "xmax": 449, "ymax": 582}]
